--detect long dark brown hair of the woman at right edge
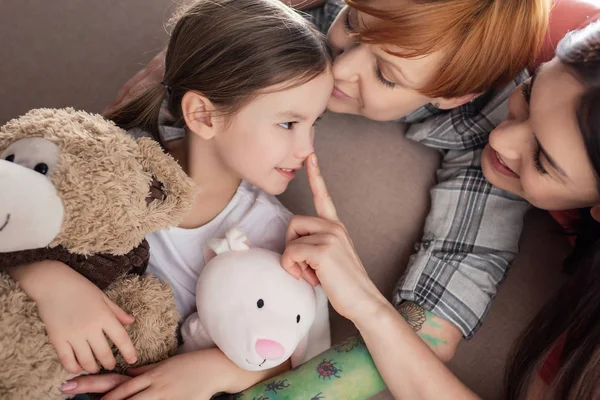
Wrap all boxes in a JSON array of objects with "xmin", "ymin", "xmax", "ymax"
[{"xmin": 506, "ymin": 21, "xmax": 600, "ymax": 400}]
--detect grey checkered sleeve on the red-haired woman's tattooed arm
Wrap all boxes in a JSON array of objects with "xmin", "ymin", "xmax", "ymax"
[{"xmin": 394, "ymin": 150, "xmax": 529, "ymax": 338}]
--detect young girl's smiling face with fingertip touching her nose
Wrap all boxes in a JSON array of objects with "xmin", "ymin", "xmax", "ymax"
[{"xmin": 215, "ymin": 69, "xmax": 333, "ymax": 195}]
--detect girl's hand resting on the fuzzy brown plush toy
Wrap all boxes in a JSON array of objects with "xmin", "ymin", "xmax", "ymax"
[{"xmin": 13, "ymin": 261, "xmax": 136, "ymax": 374}]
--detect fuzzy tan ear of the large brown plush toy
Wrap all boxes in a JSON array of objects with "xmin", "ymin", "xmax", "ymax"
[{"xmin": 137, "ymin": 138, "xmax": 195, "ymax": 232}]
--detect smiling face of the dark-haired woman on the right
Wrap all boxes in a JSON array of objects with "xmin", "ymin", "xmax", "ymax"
[{"xmin": 481, "ymin": 58, "xmax": 600, "ymax": 210}]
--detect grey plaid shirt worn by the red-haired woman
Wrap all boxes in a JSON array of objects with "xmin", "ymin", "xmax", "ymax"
[{"xmin": 152, "ymin": 0, "xmax": 530, "ymax": 338}]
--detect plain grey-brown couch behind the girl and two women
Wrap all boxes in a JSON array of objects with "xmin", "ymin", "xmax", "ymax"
[{"xmin": 0, "ymin": 0, "xmax": 568, "ymax": 399}]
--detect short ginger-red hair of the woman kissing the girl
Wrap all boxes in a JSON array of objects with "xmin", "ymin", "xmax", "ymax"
[{"xmin": 346, "ymin": 0, "xmax": 550, "ymax": 98}]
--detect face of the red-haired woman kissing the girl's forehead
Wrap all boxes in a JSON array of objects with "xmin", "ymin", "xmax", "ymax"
[{"xmin": 328, "ymin": 0, "xmax": 446, "ymax": 121}]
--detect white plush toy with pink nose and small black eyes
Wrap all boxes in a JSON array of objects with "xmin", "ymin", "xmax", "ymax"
[{"xmin": 180, "ymin": 229, "xmax": 331, "ymax": 371}]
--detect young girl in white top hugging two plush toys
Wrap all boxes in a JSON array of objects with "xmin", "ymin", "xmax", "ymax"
[{"xmin": 9, "ymin": 0, "xmax": 333, "ymax": 399}]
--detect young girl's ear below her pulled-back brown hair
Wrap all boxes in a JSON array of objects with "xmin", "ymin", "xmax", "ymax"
[{"xmin": 181, "ymin": 91, "xmax": 216, "ymax": 140}]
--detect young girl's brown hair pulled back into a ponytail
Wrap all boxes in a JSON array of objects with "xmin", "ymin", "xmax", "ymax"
[{"xmin": 106, "ymin": 0, "xmax": 331, "ymax": 142}]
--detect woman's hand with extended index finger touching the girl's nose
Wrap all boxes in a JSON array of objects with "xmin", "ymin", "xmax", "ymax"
[{"xmin": 281, "ymin": 154, "xmax": 387, "ymax": 322}]
